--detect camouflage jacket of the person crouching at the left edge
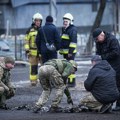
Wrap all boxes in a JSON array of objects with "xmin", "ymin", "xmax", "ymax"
[{"xmin": 0, "ymin": 58, "xmax": 13, "ymax": 90}]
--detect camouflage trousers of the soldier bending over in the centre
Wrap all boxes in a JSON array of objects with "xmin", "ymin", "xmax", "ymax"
[{"xmin": 36, "ymin": 65, "xmax": 65, "ymax": 107}]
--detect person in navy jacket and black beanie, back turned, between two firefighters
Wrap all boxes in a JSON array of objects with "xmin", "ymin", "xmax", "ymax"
[{"xmin": 36, "ymin": 16, "xmax": 61, "ymax": 63}]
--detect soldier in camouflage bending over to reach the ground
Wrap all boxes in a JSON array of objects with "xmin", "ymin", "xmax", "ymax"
[{"xmin": 33, "ymin": 59, "xmax": 77, "ymax": 113}]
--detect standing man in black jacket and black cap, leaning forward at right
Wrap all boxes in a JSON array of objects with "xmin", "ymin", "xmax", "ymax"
[{"xmin": 93, "ymin": 28, "xmax": 120, "ymax": 111}]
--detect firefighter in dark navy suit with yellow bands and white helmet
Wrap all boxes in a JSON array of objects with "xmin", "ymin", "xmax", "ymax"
[{"xmin": 59, "ymin": 13, "xmax": 77, "ymax": 87}]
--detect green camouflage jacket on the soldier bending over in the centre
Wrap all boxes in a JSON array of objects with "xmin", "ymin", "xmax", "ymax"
[{"xmin": 44, "ymin": 59, "xmax": 74, "ymax": 78}]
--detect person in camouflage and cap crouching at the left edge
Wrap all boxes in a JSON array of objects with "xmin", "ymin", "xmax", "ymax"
[{"xmin": 0, "ymin": 57, "xmax": 15, "ymax": 109}]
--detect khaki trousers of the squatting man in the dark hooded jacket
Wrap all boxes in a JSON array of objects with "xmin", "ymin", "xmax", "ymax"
[{"xmin": 80, "ymin": 92, "xmax": 102, "ymax": 111}]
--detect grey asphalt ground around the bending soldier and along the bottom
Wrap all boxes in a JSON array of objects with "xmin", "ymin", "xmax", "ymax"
[{"xmin": 0, "ymin": 60, "xmax": 120, "ymax": 120}]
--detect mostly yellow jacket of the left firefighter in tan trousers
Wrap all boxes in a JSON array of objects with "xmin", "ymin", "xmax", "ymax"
[{"xmin": 25, "ymin": 26, "xmax": 38, "ymax": 56}]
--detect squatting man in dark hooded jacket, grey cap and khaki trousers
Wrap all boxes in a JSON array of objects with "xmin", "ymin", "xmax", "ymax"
[{"xmin": 80, "ymin": 55, "xmax": 120, "ymax": 113}]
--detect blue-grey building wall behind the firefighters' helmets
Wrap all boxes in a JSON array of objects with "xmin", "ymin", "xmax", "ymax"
[{"xmin": 0, "ymin": 2, "xmax": 113, "ymax": 33}]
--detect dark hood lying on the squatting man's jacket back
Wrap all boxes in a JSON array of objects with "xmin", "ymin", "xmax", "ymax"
[{"xmin": 94, "ymin": 60, "xmax": 111, "ymax": 71}]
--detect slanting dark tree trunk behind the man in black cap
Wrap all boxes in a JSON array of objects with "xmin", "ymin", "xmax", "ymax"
[{"xmin": 84, "ymin": 0, "xmax": 106, "ymax": 55}]
